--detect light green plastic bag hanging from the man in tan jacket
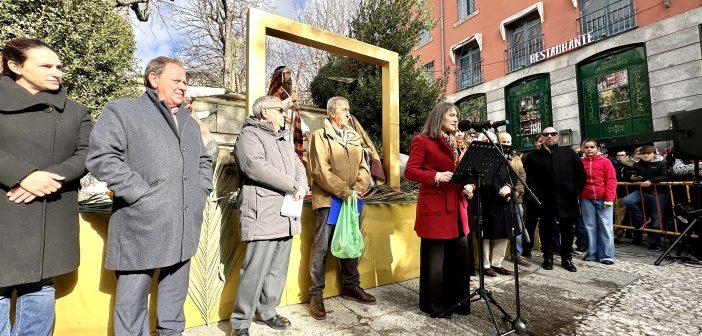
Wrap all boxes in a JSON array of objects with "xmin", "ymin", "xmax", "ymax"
[{"xmin": 331, "ymin": 194, "xmax": 365, "ymax": 259}]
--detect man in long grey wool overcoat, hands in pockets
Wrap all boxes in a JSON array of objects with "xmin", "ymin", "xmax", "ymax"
[{"xmin": 86, "ymin": 57, "xmax": 212, "ymax": 335}]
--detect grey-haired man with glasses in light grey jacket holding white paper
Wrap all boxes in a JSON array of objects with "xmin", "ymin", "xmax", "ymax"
[{"xmin": 230, "ymin": 96, "xmax": 308, "ymax": 335}]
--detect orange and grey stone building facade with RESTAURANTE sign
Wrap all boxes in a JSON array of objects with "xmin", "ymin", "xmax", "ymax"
[{"xmin": 414, "ymin": 0, "xmax": 702, "ymax": 149}]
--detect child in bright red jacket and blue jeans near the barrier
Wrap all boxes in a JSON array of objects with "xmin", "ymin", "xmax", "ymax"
[{"xmin": 580, "ymin": 140, "xmax": 617, "ymax": 265}]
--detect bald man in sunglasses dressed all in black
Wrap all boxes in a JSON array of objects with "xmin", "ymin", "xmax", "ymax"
[{"xmin": 524, "ymin": 127, "xmax": 586, "ymax": 272}]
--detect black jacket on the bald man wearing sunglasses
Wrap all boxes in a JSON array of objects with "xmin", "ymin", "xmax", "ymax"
[{"xmin": 524, "ymin": 146, "xmax": 586, "ymax": 218}]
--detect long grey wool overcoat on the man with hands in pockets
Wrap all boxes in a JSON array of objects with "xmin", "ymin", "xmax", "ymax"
[{"xmin": 86, "ymin": 89, "xmax": 212, "ymax": 271}]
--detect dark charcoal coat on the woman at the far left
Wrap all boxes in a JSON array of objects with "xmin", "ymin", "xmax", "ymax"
[{"xmin": 0, "ymin": 77, "xmax": 92, "ymax": 287}]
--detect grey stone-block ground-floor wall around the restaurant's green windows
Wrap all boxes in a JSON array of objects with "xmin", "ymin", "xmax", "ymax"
[{"xmin": 447, "ymin": 8, "xmax": 702, "ymax": 143}]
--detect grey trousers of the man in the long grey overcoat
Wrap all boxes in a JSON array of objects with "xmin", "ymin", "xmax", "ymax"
[{"xmin": 114, "ymin": 260, "xmax": 190, "ymax": 336}]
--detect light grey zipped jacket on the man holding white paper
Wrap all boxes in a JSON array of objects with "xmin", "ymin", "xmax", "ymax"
[{"xmin": 235, "ymin": 118, "xmax": 308, "ymax": 241}]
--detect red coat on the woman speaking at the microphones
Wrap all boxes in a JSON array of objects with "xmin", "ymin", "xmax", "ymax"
[{"xmin": 405, "ymin": 134, "xmax": 468, "ymax": 239}]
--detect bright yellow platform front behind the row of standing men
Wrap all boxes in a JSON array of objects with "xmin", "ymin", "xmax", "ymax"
[{"xmin": 55, "ymin": 204, "xmax": 419, "ymax": 336}]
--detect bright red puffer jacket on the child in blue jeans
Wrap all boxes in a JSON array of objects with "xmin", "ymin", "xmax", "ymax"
[{"xmin": 580, "ymin": 155, "xmax": 617, "ymax": 202}]
